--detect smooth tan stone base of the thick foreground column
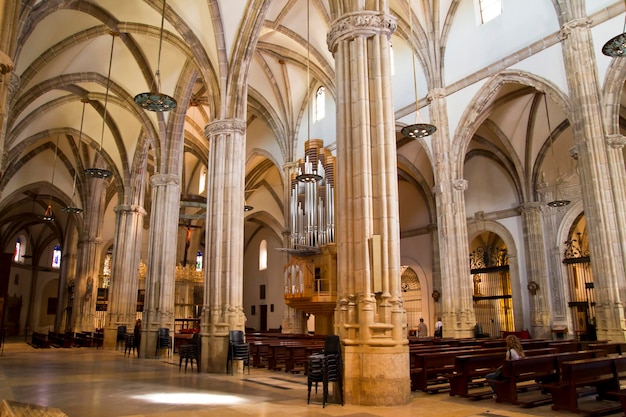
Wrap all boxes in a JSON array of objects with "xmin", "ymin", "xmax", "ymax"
[{"xmin": 343, "ymin": 345, "xmax": 411, "ymax": 406}]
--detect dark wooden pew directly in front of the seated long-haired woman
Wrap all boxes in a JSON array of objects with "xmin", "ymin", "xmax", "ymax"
[{"xmin": 448, "ymin": 348, "xmax": 556, "ymax": 399}]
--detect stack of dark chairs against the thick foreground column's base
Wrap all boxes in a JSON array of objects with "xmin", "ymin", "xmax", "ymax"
[{"xmin": 307, "ymin": 335, "xmax": 343, "ymax": 407}]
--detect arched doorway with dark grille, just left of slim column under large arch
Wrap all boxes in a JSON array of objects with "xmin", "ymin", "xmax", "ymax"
[{"xmin": 469, "ymin": 232, "xmax": 515, "ymax": 337}]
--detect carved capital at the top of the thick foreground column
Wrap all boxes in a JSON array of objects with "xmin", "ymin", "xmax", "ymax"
[{"xmin": 326, "ymin": 10, "xmax": 398, "ymax": 53}]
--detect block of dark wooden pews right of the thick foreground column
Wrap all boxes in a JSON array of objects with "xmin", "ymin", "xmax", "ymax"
[{"xmin": 410, "ymin": 339, "xmax": 626, "ymax": 415}]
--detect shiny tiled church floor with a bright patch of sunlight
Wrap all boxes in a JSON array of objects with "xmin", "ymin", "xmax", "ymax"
[{"xmin": 0, "ymin": 340, "xmax": 621, "ymax": 417}]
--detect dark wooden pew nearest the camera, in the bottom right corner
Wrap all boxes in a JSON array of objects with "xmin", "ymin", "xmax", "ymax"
[{"xmin": 541, "ymin": 357, "xmax": 626, "ymax": 414}]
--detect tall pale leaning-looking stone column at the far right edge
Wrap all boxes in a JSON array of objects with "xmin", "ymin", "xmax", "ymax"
[{"xmin": 561, "ymin": 17, "xmax": 626, "ymax": 341}]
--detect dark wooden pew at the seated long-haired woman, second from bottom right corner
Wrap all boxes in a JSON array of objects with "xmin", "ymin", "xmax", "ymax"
[{"xmin": 494, "ymin": 350, "xmax": 600, "ymax": 407}]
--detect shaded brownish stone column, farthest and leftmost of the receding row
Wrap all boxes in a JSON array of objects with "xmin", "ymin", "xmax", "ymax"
[{"xmin": 72, "ymin": 177, "xmax": 108, "ymax": 332}]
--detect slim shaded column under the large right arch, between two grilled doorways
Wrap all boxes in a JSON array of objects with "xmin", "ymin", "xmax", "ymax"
[{"xmin": 520, "ymin": 202, "xmax": 552, "ymax": 339}]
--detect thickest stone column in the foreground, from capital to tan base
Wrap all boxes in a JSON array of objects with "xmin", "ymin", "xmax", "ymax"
[{"xmin": 327, "ymin": 5, "xmax": 411, "ymax": 406}]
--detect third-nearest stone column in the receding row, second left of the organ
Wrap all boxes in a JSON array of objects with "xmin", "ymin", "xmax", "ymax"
[{"xmin": 140, "ymin": 174, "xmax": 180, "ymax": 358}]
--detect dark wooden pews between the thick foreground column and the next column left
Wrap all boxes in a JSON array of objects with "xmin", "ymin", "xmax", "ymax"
[{"xmin": 246, "ymin": 333, "xmax": 324, "ymax": 373}]
